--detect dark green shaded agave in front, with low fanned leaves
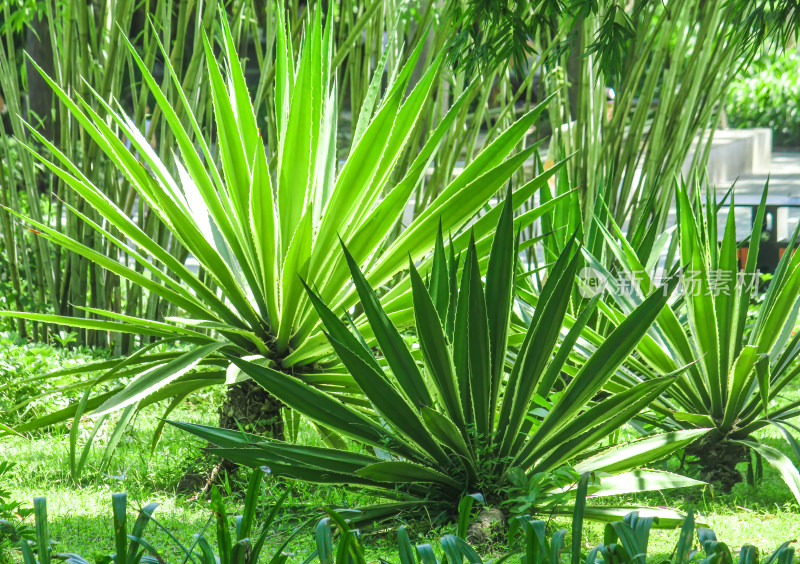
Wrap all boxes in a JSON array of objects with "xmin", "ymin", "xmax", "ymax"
[{"xmin": 175, "ymin": 195, "xmax": 705, "ymax": 522}]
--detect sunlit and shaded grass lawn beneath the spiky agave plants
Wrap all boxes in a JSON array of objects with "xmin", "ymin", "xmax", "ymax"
[{"xmin": 0, "ymin": 388, "xmax": 800, "ymax": 562}]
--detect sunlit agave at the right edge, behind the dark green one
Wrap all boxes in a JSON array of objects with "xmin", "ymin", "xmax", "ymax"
[{"xmin": 589, "ymin": 186, "xmax": 800, "ymax": 501}]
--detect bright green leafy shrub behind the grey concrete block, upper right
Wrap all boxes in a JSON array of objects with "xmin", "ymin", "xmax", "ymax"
[{"xmin": 726, "ymin": 51, "xmax": 800, "ymax": 147}]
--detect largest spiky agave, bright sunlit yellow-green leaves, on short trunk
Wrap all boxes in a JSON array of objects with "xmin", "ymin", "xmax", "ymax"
[{"xmin": 0, "ymin": 10, "xmax": 557, "ymax": 450}]
